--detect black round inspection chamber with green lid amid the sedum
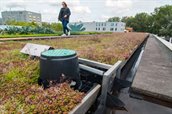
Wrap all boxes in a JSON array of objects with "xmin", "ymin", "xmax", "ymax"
[{"xmin": 38, "ymin": 49, "xmax": 80, "ymax": 87}]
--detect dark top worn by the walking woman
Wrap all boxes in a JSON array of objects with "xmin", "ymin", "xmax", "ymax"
[{"xmin": 58, "ymin": 7, "xmax": 71, "ymax": 21}]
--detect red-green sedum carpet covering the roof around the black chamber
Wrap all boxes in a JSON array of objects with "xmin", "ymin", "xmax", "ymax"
[{"xmin": 0, "ymin": 33, "xmax": 148, "ymax": 114}]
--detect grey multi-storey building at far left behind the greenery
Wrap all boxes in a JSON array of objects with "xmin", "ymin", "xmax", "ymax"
[{"xmin": 1, "ymin": 11, "xmax": 42, "ymax": 23}]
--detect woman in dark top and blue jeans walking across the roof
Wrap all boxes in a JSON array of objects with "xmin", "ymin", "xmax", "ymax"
[{"xmin": 58, "ymin": 2, "xmax": 71, "ymax": 36}]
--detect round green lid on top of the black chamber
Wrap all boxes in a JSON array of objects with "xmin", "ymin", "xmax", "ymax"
[{"xmin": 41, "ymin": 49, "xmax": 76, "ymax": 58}]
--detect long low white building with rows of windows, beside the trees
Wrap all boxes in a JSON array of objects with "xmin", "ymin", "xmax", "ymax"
[{"xmin": 71, "ymin": 22, "xmax": 126, "ymax": 32}]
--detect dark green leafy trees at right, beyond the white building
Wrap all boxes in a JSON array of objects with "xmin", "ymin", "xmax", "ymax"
[{"xmin": 108, "ymin": 5, "xmax": 172, "ymax": 37}]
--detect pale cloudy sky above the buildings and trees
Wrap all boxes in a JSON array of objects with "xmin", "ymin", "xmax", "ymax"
[{"xmin": 0, "ymin": 0, "xmax": 172, "ymax": 22}]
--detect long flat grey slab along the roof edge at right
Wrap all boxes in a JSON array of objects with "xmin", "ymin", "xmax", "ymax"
[{"xmin": 131, "ymin": 36, "xmax": 172, "ymax": 102}]
